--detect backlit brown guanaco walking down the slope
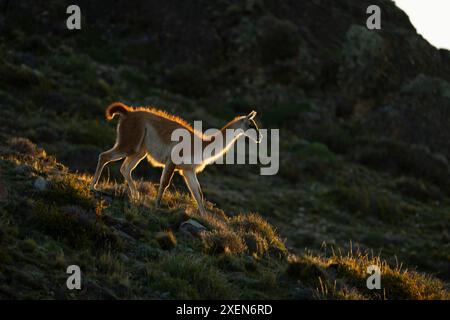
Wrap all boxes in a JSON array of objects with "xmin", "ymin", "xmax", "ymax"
[{"xmin": 91, "ymin": 102, "xmax": 261, "ymax": 214}]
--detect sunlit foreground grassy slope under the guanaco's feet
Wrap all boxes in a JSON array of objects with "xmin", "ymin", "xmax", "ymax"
[{"xmin": 0, "ymin": 138, "xmax": 449, "ymax": 299}]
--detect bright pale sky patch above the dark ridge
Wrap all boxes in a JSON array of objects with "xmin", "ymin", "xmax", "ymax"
[{"xmin": 392, "ymin": 0, "xmax": 450, "ymax": 50}]
